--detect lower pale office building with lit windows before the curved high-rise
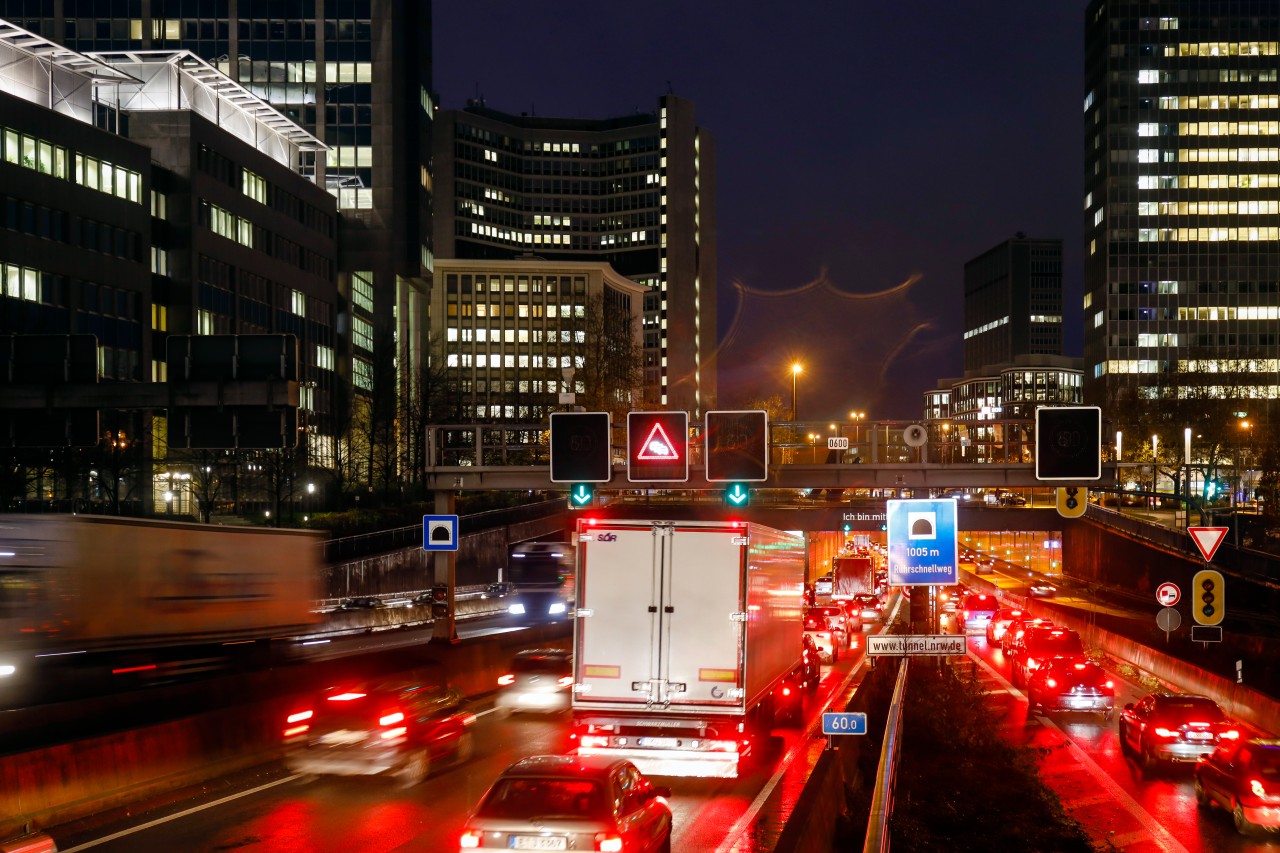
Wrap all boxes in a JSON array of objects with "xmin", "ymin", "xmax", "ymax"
[{"xmin": 431, "ymin": 257, "xmax": 646, "ymax": 424}]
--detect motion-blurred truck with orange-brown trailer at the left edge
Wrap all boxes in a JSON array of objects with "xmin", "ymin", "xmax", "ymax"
[{"xmin": 0, "ymin": 515, "xmax": 324, "ymax": 684}]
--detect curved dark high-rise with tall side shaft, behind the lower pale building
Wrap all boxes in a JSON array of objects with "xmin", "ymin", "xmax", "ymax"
[{"xmin": 433, "ymin": 95, "xmax": 716, "ymax": 416}]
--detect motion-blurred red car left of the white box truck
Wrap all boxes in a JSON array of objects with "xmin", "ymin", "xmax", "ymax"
[{"xmin": 283, "ymin": 669, "xmax": 475, "ymax": 786}]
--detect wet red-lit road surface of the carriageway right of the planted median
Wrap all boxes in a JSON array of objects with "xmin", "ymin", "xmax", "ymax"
[{"xmin": 969, "ymin": 614, "xmax": 1280, "ymax": 853}]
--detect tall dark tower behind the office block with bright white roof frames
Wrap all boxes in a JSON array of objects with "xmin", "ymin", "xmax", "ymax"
[{"xmin": 0, "ymin": 0, "xmax": 434, "ymax": 417}]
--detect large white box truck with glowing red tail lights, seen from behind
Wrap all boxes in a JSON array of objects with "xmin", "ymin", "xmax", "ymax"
[{"xmin": 571, "ymin": 519, "xmax": 805, "ymax": 777}]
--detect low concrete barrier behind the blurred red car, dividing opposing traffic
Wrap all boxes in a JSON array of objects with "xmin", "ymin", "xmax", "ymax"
[{"xmin": 0, "ymin": 625, "xmax": 570, "ymax": 839}]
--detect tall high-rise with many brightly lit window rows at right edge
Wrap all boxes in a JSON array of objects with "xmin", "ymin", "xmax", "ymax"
[{"xmin": 1083, "ymin": 0, "xmax": 1280, "ymax": 412}]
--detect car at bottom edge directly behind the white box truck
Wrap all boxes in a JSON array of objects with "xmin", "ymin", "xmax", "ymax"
[{"xmin": 458, "ymin": 756, "xmax": 671, "ymax": 853}]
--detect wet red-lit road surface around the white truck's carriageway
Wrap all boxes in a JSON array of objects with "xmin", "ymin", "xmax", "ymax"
[{"xmin": 51, "ymin": 637, "xmax": 861, "ymax": 853}]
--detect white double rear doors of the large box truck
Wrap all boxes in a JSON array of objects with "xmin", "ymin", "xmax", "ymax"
[{"xmin": 573, "ymin": 521, "xmax": 746, "ymax": 708}]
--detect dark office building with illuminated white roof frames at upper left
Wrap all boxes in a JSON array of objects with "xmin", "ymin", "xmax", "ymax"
[{"xmin": 0, "ymin": 22, "xmax": 339, "ymax": 512}]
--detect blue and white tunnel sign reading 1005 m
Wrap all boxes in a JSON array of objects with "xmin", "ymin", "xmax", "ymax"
[{"xmin": 886, "ymin": 498, "xmax": 960, "ymax": 587}]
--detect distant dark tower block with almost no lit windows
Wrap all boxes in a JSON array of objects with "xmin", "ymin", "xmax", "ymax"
[{"xmin": 964, "ymin": 233, "xmax": 1062, "ymax": 371}]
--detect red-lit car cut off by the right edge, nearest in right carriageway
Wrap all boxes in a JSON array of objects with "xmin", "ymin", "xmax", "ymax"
[{"xmin": 1196, "ymin": 738, "xmax": 1280, "ymax": 835}]
